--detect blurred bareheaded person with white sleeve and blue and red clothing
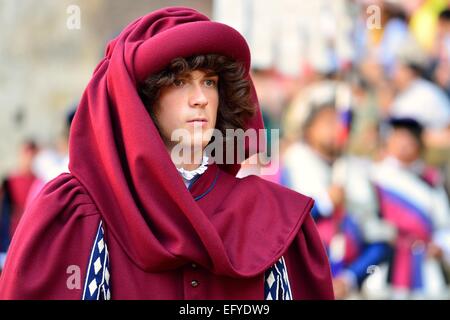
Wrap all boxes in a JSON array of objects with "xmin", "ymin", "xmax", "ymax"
[{"xmin": 282, "ymin": 97, "xmax": 388, "ymax": 299}]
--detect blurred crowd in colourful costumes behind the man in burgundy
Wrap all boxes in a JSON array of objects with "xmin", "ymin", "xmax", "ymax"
[{"xmin": 0, "ymin": 0, "xmax": 450, "ymax": 299}]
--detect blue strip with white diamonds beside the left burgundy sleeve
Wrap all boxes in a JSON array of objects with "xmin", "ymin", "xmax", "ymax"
[{"xmin": 82, "ymin": 221, "xmax": 111, "ymax": 300}]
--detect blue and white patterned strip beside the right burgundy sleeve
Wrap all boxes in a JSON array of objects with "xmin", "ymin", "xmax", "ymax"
[{"xmin": 264, "ymin": 257, "xmax": 292, "ymax": 300}]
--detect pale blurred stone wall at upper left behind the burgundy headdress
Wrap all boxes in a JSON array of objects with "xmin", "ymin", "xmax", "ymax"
[{"xmin": 0, "ymin": 0, "xmax": 212, "ymax": 176}]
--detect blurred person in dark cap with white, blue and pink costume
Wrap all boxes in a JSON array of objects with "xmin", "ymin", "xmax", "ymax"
[{"xmin": 372, "ymin": 118, "xmax": 450, "ymax": 299}]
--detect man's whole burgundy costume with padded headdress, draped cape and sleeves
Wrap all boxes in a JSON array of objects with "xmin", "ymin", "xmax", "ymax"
[{"xmin": 0, "ymin": 7, "xmax": 333, "ymax": 299}]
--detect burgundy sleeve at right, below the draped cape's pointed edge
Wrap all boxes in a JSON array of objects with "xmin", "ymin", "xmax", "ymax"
[{"xmin": 284, "ymin": 214, "xmax": 334, "ymax": 300}]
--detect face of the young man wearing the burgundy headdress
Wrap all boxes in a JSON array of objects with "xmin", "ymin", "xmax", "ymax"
[{"xmin": 154, "ymin": 70, "xmax": 219, "ymax": 150}]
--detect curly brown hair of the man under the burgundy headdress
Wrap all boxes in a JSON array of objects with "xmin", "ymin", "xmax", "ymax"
[{"xmin": 138, "ymin": 54, "xmax": 255, "ymax": 134}]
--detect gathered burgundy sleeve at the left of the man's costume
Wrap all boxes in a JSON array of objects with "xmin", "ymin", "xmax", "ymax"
[{"xmin": 0, "ymin": 174, "xmax": 100, "ymax": 299}]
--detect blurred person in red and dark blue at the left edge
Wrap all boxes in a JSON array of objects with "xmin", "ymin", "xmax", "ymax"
[{"xmin": 0, "ymin": 140, "xmax": 38, "ymax": 270}]
